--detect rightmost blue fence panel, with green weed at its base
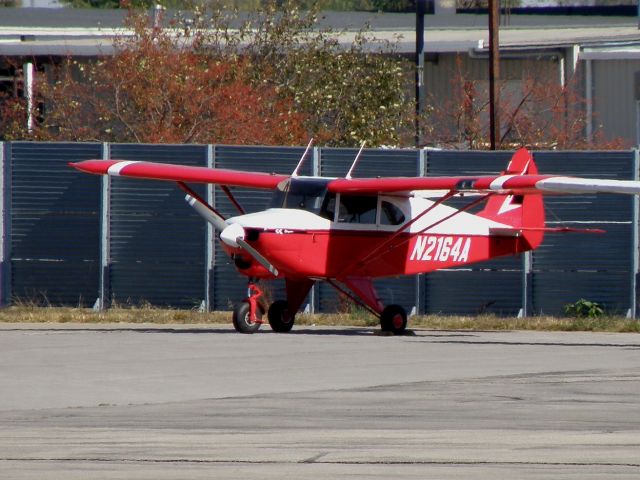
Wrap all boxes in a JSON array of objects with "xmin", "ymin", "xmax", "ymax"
[{"xmin": 532, "ymin": 152, "xmax": 634, "ymax": 315}]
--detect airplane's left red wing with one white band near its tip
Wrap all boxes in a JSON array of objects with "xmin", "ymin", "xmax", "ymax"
[{"xmin": 69, "ymin": 160, "xmax": 289, "ymax": 189}]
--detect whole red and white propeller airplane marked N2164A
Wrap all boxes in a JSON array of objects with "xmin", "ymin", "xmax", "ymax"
[{"xmin": 69, "ymin": 142, "xmax": 640, "ymax": 334}]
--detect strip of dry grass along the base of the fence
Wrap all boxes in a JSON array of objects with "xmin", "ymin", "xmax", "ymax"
[{"xmin": 0, "ymin": 305, "xmax": 640, "ymax": 333}]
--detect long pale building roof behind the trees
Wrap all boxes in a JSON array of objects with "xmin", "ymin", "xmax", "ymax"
[{"xmin": 0, "ymin": 8, "xmax": 640, "ymax": 56}]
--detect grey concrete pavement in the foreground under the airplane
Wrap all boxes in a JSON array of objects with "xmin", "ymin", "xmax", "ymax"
[{"xmin": 0, "ymin": 324, "xmax": 640, "ymax": 479}]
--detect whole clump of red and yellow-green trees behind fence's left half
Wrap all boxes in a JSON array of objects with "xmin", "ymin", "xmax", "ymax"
[{"xmin": 5, "ymin": 2, "xmax": 412, "ymax": 146}]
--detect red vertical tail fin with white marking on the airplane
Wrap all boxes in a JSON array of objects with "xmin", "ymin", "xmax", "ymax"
[{"xmin": 479, "ymin": 148, "xmax": 545, "ymax": 248}]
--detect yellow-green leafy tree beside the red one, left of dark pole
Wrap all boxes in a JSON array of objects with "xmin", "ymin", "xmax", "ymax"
[{"xmin": 236, "ymin": 2, "xmax": 413, "ymax": 146}]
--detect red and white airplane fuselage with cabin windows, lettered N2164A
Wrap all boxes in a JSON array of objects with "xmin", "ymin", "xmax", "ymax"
[{"xmin": 222, "ymin": 177, "xmax": 529, "ymax": 279}]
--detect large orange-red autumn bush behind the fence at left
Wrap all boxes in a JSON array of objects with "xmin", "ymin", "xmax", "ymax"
[{"xmin": 3, "ymin": 9, "xmax": 306, "ymax": 144}]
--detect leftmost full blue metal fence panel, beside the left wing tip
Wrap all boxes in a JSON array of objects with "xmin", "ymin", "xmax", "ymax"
[{"xmin": 5, "ymin": 142, "xmax": 101, "ymax": 305}]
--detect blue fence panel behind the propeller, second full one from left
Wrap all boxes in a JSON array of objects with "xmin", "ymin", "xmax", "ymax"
[{"xmin": 109, "ymin": 144, "xmax": 207, "ymax": 308}]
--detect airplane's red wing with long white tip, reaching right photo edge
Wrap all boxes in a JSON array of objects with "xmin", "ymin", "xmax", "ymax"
[{"xmin": 328, "ymin": 175, "xmax": 640, "ymax": 195}]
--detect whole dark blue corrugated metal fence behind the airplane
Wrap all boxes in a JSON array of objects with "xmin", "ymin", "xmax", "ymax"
[{"xmin": 0, "ymin": 142, "xmax": 639, "ymax": 316}]
